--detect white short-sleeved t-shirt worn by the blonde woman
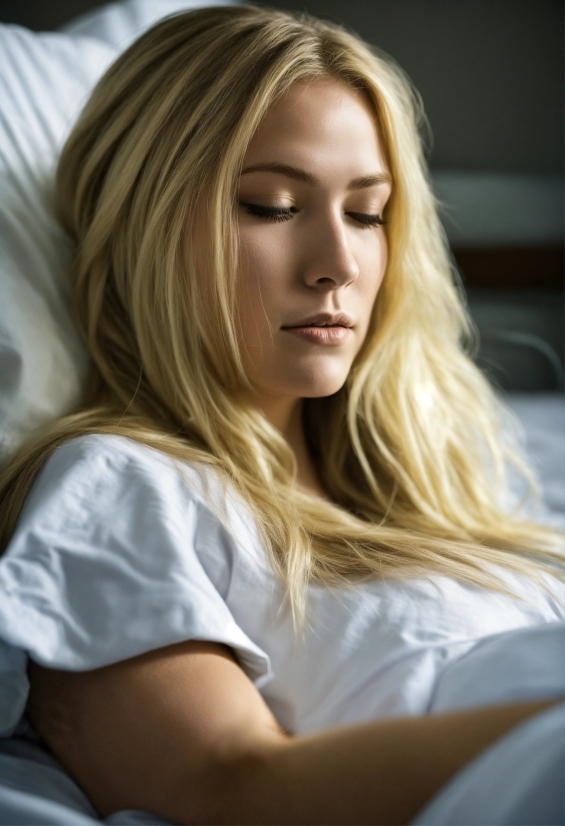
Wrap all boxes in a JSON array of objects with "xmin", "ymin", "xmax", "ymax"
[{"xmin": 0, "ymin": 435, "xmax": 565, "ymax": 734}]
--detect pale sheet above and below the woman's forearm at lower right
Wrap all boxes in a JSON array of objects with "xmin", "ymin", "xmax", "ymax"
[{"xmin": 413, "ymin": 623, "xmax": 565, "ymax": 826}]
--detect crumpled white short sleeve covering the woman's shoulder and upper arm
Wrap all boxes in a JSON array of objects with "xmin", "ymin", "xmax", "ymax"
[{"xmin": 0, "ymin": 436, "xmax": 270, "ymax": 730}]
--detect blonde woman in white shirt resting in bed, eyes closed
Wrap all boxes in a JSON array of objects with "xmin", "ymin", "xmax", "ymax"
[{"xmin": 0, "ymin": 6, "xmax": 563, "ymax": 823}]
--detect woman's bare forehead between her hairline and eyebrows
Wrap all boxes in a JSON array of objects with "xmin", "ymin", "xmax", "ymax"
[{"xmin": 244, "ymin": 78, "xmax": 387, "ymax": 177}]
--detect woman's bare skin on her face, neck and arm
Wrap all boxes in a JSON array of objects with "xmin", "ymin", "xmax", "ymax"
[{"xmin": 28, "ymin": 81, "xmax": 554, "ymax": 824}]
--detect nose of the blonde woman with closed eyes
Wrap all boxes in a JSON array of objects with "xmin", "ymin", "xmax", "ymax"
[{"xmin": 303, "ymin": 215, "xmax": 359, "ymax": 290}]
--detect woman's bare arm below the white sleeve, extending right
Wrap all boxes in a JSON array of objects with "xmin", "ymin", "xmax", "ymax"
[{"xmin": 29, "ymin": 642, "xmax": 551, "ymax": 824}]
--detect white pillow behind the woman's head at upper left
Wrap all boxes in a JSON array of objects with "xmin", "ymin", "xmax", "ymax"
[{"xmin": 0, "ymin": 0, "xmax": 235, "ymax": 461}]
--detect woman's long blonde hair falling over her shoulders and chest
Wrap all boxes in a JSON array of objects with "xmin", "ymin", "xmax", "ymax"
[{"xmin": 0, "ymin": 6, "xmax": 559, "ymax": 615}]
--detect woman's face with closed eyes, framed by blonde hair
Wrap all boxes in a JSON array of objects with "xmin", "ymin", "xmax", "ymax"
[{"xmin": 238, "ymin": 78, "xmax": 391, "ymax": 418}]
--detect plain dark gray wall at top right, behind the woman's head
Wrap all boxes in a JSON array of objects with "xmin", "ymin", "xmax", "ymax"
[{"xmin": 258, "ymin": 0, "xmax": 563, "ymax": 174}]
